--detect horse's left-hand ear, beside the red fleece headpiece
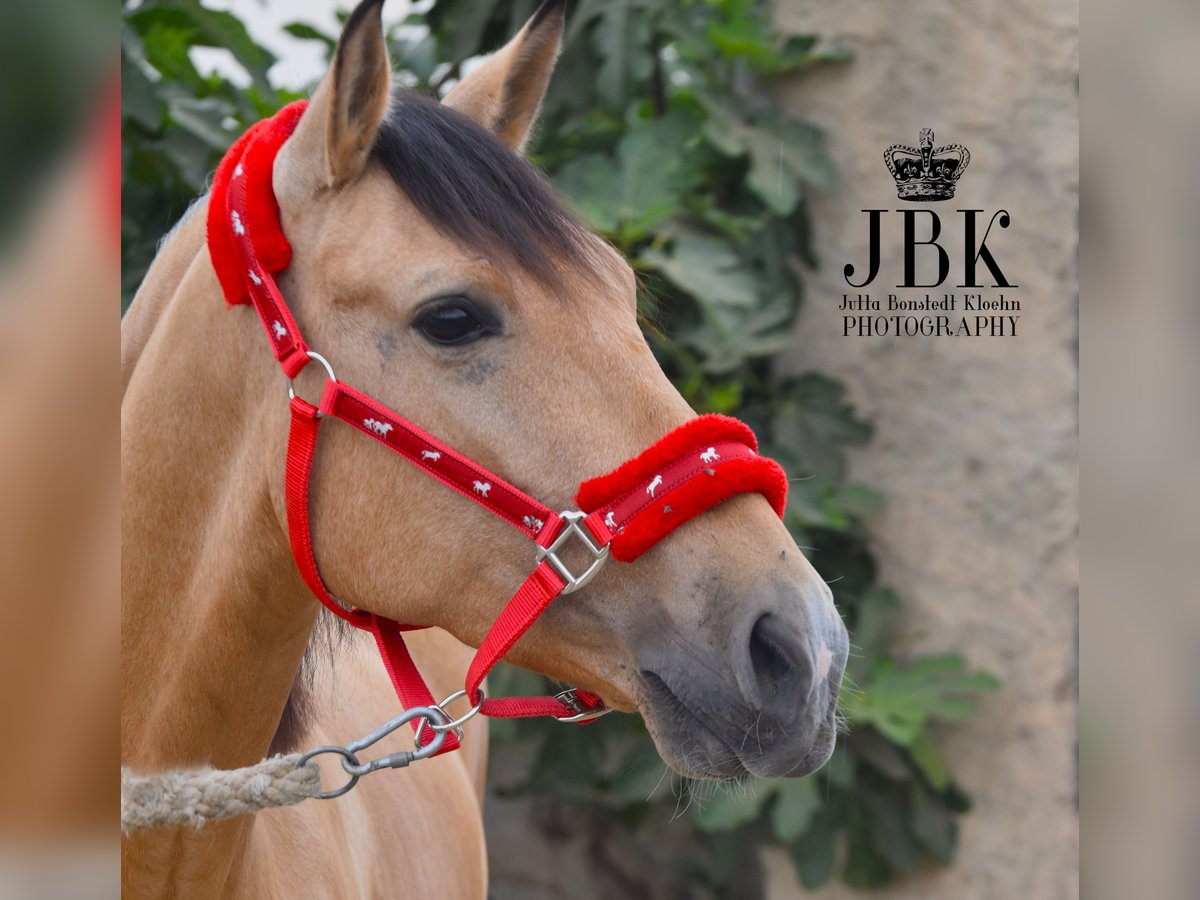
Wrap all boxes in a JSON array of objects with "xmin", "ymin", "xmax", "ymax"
[{"xmin": 276, "ymin": 0, "xmax": 391, "ymax": 190}]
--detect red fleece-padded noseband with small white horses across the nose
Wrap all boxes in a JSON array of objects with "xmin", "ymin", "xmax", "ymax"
[{"xmin": 576, "ymin": 415, "xmax": 787, "ymax": 563}]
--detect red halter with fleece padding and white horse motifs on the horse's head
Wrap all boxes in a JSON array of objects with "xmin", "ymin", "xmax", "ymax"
[{"xmin": 208, "ymin": 101, "xmax": 787, "ymax": 752}]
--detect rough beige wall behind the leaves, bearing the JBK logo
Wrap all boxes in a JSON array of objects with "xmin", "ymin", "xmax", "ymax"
[{"xmin": 768, "ymin": 0, "xmax": 1078, "ymax": 900}]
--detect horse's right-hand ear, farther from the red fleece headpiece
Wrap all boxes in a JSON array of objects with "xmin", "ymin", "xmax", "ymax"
[{"xmin": 444, "ymin": 0, "xmax": 566, "ymax": 152}]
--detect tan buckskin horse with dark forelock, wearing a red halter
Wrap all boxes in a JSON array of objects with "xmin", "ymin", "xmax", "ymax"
[{"xmin": 121, "ymin": 0, "xmax": 847, "ymax": 900}]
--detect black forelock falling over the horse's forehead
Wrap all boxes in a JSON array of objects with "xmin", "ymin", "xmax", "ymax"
[{"xmin": 371, "ymin": 91, "xmax": 593, "ymax": 286}]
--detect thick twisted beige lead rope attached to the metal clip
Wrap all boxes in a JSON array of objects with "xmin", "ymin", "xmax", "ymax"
[{"xmin": 121, "ymin": 754, "xmax": 320, "ymax": 834}]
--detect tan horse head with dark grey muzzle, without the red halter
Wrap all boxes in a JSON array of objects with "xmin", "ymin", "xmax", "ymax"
[{"xmin": 266, "ymin": 0, "xmax": 847, "ymax": 776}]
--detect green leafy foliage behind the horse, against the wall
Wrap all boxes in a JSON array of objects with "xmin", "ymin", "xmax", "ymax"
[{"xmin": 121, "ymin": 0, "xmax": 995, "ymax": 896}]
